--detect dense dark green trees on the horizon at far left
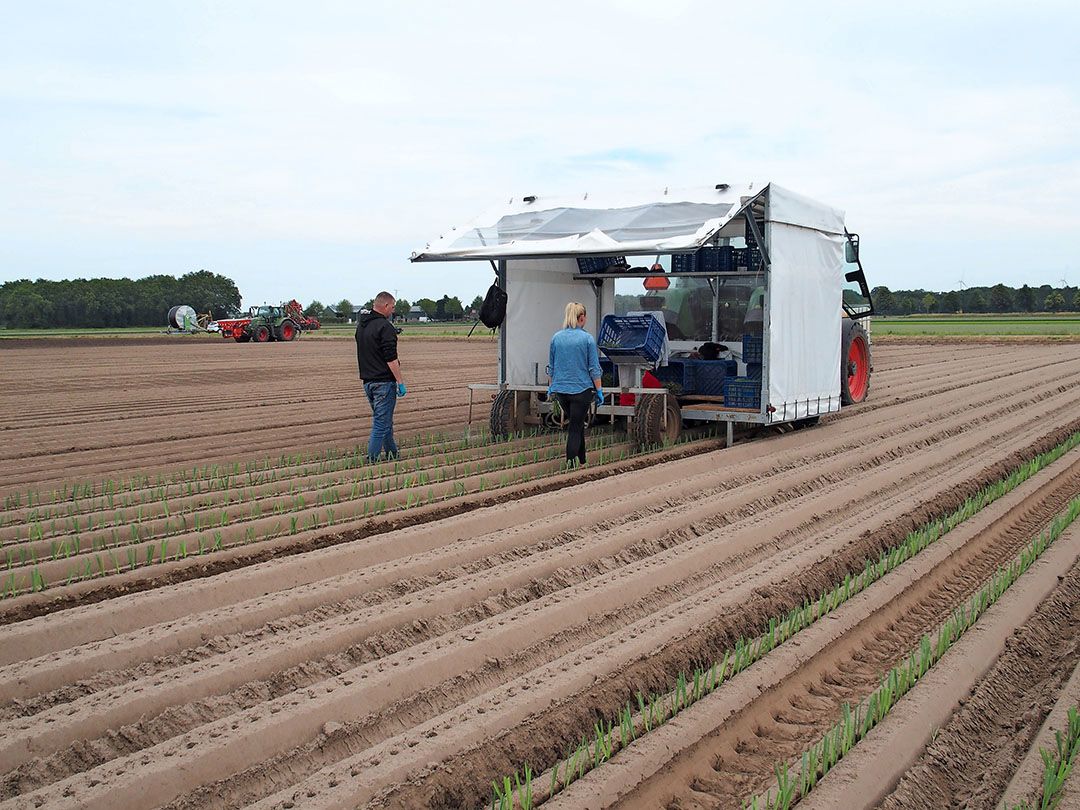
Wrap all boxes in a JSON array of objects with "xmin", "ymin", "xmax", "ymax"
[{"xmin": 0, "ymin": 270, "xmax": 240, "ymax": 328}]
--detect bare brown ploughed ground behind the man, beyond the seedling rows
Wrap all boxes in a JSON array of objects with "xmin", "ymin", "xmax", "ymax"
[{"xmin": 0, "ymin": 337, "xmax": 496, "ymax": 491}]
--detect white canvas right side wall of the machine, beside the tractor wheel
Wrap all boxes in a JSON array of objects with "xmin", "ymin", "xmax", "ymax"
[{"xmin": 766, "ymin": 223, "xmax": 843, "ymax": 422}]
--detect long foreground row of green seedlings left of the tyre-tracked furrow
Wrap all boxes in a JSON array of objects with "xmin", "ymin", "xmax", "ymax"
[{"xmin": 491, "ymin": 431, "xmax": 1080, "ymax": 810}]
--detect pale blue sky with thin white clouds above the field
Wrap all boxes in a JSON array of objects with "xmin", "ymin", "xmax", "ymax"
[{"xmin": 0, "ymin": 0, "xmax": 1080, "ymax": 306}]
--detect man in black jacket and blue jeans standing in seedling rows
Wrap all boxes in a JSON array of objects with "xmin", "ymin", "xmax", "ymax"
[{"xmin": 356, "ymin": 293, "xmax": 406, "ymax": 461}]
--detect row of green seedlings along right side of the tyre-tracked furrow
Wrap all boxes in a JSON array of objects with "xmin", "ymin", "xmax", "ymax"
[{"xmin": 743, "ymin": 497, "xmax": 1080, "ymax": 810}]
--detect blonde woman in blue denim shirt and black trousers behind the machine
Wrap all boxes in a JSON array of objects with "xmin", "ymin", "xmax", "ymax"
[{"xmin": 548, "ymin": 301, "xmax": 604, "ymax": 464}]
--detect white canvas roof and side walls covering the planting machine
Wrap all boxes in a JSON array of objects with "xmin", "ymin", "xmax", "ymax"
[{"xmin": 411, "ymin": 183, "xmax": 846, "ymax": 422}]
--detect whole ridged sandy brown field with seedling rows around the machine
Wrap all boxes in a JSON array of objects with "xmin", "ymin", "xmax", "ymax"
[{"xmin": 0, "ymin": 340, "xmax": 1080, "ymax": 810}]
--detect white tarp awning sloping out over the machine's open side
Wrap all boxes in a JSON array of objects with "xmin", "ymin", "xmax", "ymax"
[{"xmin": 411, "ymin": 183, "xmax": 767, "ymax": 261}]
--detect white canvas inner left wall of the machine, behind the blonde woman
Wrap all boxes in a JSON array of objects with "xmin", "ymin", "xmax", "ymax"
[{"xmin": 502, "ymin": 259, "xmax": 613, "ymax": 386}]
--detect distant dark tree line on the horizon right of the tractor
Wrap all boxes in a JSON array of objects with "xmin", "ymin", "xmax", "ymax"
[{"xmin": 870, "ymin": 284, "xmax": 1080, "ymax": 315}]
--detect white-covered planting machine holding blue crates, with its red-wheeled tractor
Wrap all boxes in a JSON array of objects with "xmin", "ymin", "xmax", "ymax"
[{"xmin": 411, "ymin": 183, "xmax": 874, "ymax": 446}]
